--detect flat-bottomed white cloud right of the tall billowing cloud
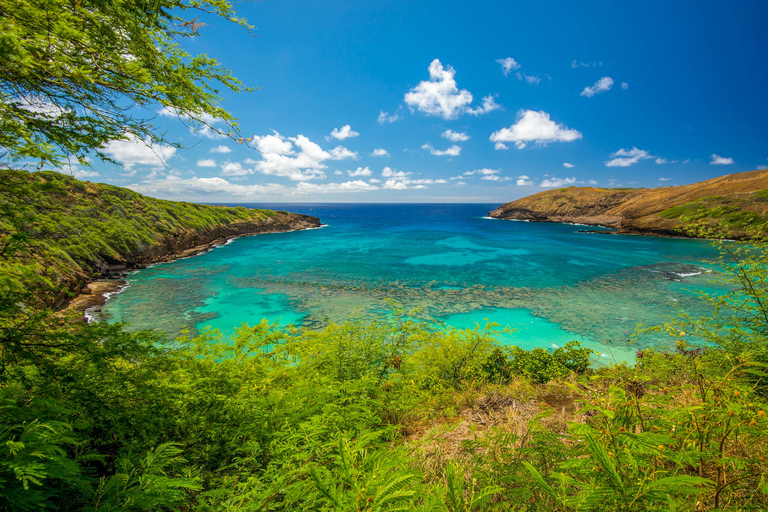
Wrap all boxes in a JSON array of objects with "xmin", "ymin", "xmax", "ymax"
[{"xmin": 490, "ymin": 110, "xmax": 582, "ymax": 149}]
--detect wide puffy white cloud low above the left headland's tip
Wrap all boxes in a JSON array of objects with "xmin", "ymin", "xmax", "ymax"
[{"xmin": 253, "ymin": 132, "xmax": 359, "ymax": 181}]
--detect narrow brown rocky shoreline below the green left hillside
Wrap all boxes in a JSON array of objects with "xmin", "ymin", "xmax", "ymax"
[{"xmin": 61, "ymin": 216, "xmax": 324, "ymax": 322}]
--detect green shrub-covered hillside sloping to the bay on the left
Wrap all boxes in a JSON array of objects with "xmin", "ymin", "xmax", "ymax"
[{"xmin": 0, "ymin": 170, "xmax": 318, "ymax": 306}]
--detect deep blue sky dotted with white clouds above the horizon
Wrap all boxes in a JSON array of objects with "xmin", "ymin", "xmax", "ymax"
[{"xmin": 70, "ymin": 0, "xmax": 768, "ymax": 203}]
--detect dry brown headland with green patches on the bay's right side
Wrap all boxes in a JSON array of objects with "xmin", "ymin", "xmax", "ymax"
[{"xmin": 489, "ymin": 170, "xmax": 768, "ymax": 238}]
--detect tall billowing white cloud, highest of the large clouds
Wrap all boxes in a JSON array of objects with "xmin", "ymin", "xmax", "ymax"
[{"xmin": 402, "ymin": 59, "xmax": 499, "ymax": 119}]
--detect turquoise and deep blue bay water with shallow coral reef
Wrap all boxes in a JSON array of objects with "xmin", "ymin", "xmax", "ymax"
[{"xmin": 102, "ymin": 204, "xmax": 728, "ymax": 360}]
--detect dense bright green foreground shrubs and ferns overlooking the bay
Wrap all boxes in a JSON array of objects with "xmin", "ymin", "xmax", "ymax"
[{"xmin": 0, "ymin": 197, "xmax": 768, "ymax": 511}]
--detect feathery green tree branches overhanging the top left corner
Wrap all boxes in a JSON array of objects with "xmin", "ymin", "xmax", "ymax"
[{"xmin": 0, "ymin": 0, "xmax": 250, "ymax": 167}]
